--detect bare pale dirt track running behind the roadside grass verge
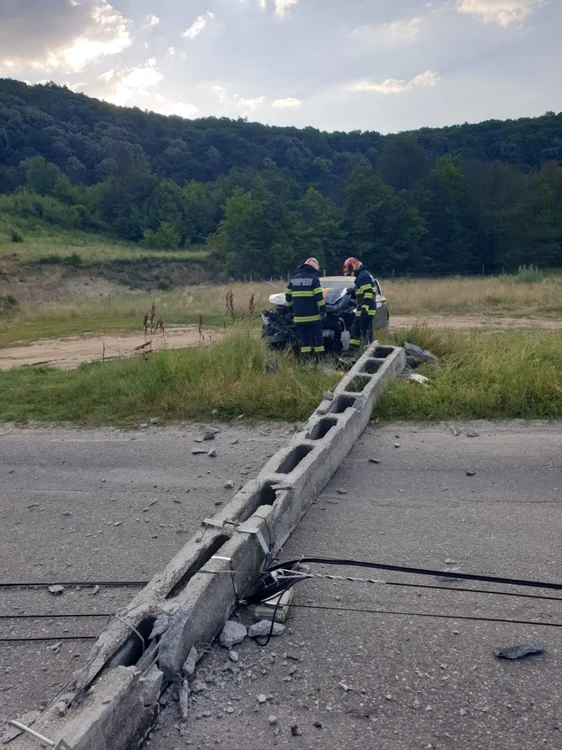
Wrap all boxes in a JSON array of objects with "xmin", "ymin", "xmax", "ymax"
[{"xmin": 0, "ymin": 316, "xmax": 562, "ymax": 370}]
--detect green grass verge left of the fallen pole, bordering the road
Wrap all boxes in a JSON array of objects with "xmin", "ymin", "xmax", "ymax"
[{"xmin": 0, "ymin": 329, "xmax": 338, "ymax": 426}]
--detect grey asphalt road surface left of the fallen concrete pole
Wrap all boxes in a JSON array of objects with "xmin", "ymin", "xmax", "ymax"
[{"xmin": 0, "ymin": 423, "xmax": 291, "ymax": 725}]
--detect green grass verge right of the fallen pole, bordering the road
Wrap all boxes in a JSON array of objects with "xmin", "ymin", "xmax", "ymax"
[{"xmin": 376, "ymin": 328, "xmax": 562, "ymax": 420}]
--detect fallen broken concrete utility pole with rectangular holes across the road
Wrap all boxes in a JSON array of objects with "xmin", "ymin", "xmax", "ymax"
[{"xmin": 10, "ymin": 343, "xmax": 406, "ymax": 750}]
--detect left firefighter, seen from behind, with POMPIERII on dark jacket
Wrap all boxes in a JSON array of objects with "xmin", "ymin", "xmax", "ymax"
[{"xmin": 285, "ymin": 258, "xmax": 326, "ymax": 359}]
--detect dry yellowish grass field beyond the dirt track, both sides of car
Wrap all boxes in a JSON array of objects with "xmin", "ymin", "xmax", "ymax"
[{"xmin": 0, "ymin": 275, "xmax": 562, "ymax": 346}]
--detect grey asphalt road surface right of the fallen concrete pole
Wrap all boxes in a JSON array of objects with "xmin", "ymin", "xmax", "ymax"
[{"xmin": 145, "ymin": 423, "xmax": 562, "ymax": 750}]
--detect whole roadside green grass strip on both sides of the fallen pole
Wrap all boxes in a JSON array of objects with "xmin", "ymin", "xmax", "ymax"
[{"xmin": 0, "ymin": 326, "xmax": 562, "ymax": 426}]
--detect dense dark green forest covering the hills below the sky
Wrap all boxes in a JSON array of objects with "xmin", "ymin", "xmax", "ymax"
[{"xmin": 0, "ymin": 79, "xmax": 562, "ymax": 277}]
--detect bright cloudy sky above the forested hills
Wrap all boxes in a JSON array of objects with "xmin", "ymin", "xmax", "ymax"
[{"xmin": 0, "ymin": 0, "xmax": 562, "ymax": 133}]
